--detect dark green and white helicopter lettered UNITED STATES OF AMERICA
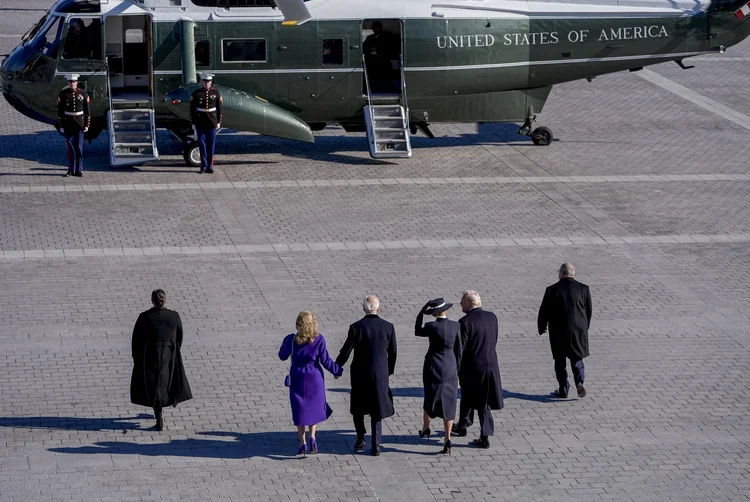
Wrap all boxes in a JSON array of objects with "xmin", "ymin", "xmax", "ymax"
[{"xmin": 0, "ymin": 0, "xmax": 750, "ymax": 166}]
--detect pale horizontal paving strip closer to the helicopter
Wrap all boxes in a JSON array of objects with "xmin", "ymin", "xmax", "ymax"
[{"xmin": 0, "ymin": 175, "xmax": 750, "ymax": 194}]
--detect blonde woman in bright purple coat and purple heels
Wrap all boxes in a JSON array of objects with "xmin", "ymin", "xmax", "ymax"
[{"xmin": 279, "ymin": 311, "xmax": 344, "ymax": 455}]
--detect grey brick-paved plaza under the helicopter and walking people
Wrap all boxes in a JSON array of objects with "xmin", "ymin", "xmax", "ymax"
[{"xmin": 0, "ymin": 0, "xmax": 750, "ymax": 502}]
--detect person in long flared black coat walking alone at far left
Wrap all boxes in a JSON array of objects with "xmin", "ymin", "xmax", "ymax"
[{"xmin": 130, "ymin": 289, "xmax": 193, "ymax": 431}]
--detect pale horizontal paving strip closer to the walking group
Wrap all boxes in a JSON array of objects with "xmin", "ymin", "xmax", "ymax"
[{"xmin": 0, "ymin": 233, "xmax": 750, "ymax": 260}]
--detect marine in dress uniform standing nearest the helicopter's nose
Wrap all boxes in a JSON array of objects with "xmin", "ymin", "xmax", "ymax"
[{"xmin": 56, "ymin": 74, "xmax": 91, "ymax": 176}]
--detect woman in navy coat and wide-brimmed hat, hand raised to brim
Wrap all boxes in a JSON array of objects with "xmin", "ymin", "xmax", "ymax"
[{"xmin": 414, "ymin": 298, "xmax": 461, "ymax": 455}]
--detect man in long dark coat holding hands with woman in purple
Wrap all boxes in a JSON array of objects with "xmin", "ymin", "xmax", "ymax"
[{"xmin": 336, "ymin": 295, "xmax": 396, "ymax": 456}]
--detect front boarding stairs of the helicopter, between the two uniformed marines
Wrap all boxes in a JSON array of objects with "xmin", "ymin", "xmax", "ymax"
[{"xmin": 107, "ymin": 95, "xmax": 159, "ymax": 166}]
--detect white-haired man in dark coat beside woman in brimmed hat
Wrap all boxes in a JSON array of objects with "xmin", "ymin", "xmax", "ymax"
[{"xmin": 453, "ymin": 290, "xmax": 503, "ymax": 448}]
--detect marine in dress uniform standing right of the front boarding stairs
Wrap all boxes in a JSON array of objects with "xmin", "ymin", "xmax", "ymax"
[{"xmin": 190, "ymin": 73, "xmax": 223, "ymax": 173}]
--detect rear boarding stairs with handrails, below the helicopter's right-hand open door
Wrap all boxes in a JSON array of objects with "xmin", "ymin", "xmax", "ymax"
[{"xmin": 362, "ymin": 57, "xmax": 411, "ymax": 159}]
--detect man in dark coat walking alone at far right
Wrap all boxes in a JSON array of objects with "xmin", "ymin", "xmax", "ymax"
[{"xmin": 537, "ymin": 263, "xmax": 591, "ymax": 398}]
